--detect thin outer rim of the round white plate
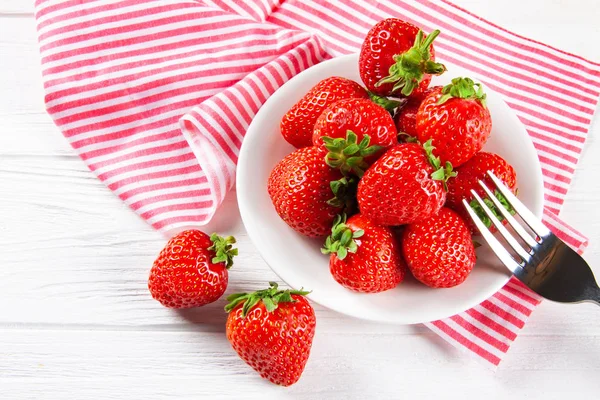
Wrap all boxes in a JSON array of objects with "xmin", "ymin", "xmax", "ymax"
[{"xmin": 236, "ymin": 53, "xmax": 544, "ymax": 325}]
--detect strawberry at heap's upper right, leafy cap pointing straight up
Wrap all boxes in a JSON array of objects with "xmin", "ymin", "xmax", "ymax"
[{"xmin": 417, "ymin": 78, "xmax": 492, "ymax": 168}]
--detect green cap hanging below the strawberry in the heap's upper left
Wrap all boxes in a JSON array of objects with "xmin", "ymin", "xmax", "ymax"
[{"xmin": 321, "ymin": 130, "xmax": 383, "ymax": 178}]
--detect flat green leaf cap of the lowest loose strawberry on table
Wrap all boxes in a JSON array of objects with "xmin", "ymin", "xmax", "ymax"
[{"xmin": 225, "ymin": 282, "xmax": 310, "ymax": 318}]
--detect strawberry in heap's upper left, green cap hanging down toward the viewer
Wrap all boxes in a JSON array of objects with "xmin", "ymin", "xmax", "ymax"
[{"xmin": 313, "ymin": 99, "xmax": 398, "ymax": 176}]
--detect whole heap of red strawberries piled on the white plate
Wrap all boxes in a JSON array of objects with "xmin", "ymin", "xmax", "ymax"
[{"xmin": 268, "ymin": 19, "xmax": 516, "ymax": 293}]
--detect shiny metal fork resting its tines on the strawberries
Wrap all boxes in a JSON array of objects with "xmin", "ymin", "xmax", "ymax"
[{"xmin": 462, "ymin": 171, "xmax": 600, "ymax": 305}]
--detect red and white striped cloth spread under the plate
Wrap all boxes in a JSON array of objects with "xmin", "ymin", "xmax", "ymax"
[{"xmin": 35, "ymin": 0, "xmax": 600, "ymax": 365}]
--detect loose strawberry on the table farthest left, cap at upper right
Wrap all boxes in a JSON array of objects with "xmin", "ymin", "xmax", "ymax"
[{"xmin": 148, "ymin": 230, "xmax": 238, "ymax": 308}]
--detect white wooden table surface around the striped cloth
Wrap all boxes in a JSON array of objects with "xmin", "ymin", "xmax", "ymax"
[{"xmin": 0, "ymin": 0, "xmax": 600, "ymax": 400}]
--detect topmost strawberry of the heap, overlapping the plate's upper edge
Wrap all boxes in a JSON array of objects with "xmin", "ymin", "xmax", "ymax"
[{"xmin": 358, "ymin": 18, "xmax": 446, "ymax": 96}]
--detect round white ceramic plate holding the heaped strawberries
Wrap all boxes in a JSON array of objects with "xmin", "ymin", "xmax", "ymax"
[{"xmin": 237, "ymin": 54, "xmax": 543, "ymax": 324}]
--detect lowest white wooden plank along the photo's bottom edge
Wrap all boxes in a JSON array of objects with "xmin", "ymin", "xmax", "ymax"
[{"xmin": 0, "ymin": 328, "xmax": 600, "ymax": 400}]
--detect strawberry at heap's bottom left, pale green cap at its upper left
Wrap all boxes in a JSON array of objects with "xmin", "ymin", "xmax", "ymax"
[{"xmin": 321, "ymin": 214, "xmax": 406, "ymax": 293}]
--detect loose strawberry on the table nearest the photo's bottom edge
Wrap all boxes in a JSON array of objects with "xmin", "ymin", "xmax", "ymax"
[{"xmin": 225, "ymin": 282, "xmax": 317, "ymax": 386}]
